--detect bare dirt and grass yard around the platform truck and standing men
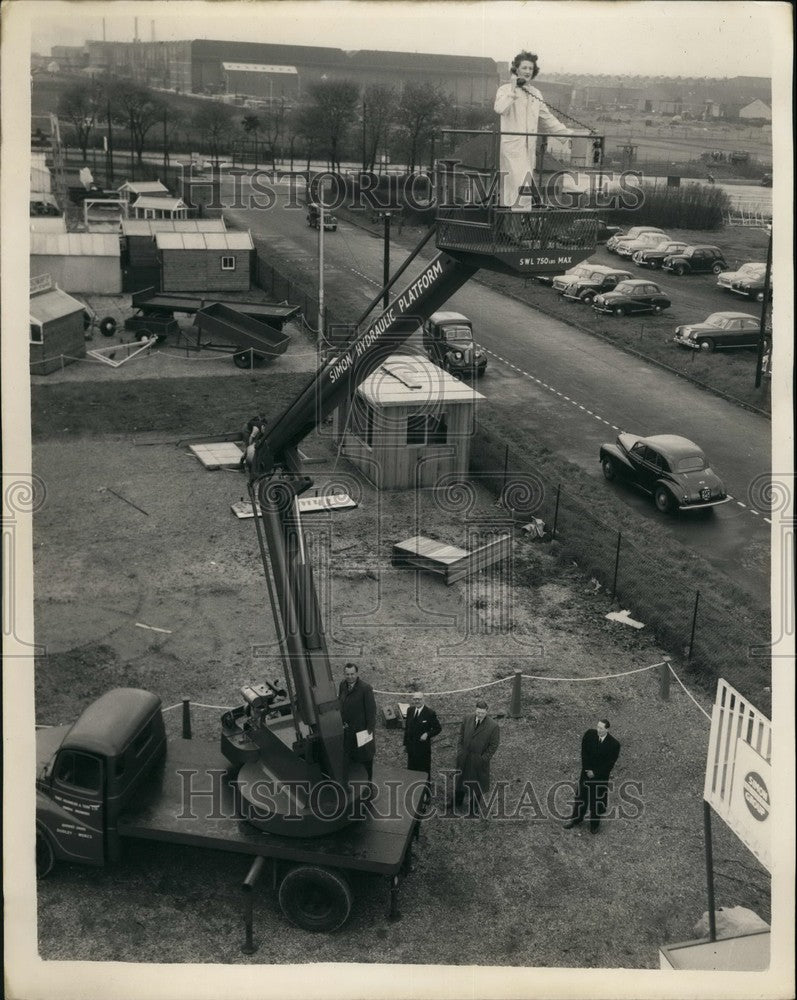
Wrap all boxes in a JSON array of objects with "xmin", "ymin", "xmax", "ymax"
[{"xmin": 34, "ymin": 347, "xmax": 769, "ymax": 968}]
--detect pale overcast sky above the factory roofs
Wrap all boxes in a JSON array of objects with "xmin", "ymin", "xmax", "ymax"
[{"xmin": 22, "ymin": 0, "xmax": 776, "ymax": 77}]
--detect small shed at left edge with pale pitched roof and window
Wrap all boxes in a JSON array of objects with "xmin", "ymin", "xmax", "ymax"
[{"xmin": 30, "ymin": 276, "xmax": 86, "ymax": 375}]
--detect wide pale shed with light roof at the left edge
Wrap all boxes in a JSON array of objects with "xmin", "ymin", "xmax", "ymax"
[{"xmin": 30, "ymin": 233, "xmax": 122, "ymax": 295}]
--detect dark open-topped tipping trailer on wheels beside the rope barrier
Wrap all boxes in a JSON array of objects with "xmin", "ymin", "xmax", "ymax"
[{"xmin": 183, "ymin": 302, "xmax": 290, "ymax": 368}]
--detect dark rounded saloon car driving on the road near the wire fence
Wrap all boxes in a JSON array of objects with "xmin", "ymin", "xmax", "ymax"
[{"xmin": 600, "ymin": 434, "xmax": 729, "ymax": 514}]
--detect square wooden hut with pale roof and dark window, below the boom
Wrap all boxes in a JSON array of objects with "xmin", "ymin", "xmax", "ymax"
[{"xmin": 334, "ymin": 354, "xmax": 484, "ymax": 490}]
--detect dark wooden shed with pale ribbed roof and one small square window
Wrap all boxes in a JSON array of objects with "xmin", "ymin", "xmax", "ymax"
[{"xmin": 155, "ymin": 232, "xmax": 255, "ymax": 292}]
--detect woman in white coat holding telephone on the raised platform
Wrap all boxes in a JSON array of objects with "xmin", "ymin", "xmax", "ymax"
[{"xmin": 494, "ymin": 52, "xmax": 572, "ymax": 212}]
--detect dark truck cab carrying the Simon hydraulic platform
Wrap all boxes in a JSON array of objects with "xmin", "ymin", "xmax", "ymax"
[{"xmin": 36, "ymin": 688, "xmax": 166, "ymax": 876}]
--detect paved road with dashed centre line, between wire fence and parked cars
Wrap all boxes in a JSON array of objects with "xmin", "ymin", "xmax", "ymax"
[{"xmin": 225, "ymin": 178, "xmax": 770, "ymax": 605}]
